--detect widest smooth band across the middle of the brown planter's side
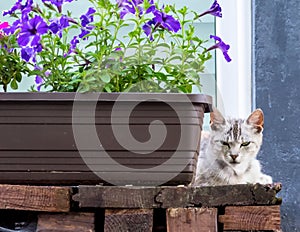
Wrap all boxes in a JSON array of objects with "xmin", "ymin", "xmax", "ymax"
[{"xmin": 0, "ymin": 124, "xmax": 200, "ymax": 150}]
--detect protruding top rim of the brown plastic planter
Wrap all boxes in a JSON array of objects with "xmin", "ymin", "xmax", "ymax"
[{"xmin": 0, "ymin": 92, "xmax": 213, "ymax": 105}]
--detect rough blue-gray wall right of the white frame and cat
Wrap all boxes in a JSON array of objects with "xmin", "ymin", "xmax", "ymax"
[{"xmin": 253, "ymin": 0, "xmax": 300, "ymax": 232}]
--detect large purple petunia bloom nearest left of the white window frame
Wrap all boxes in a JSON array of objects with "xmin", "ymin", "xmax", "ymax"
[{"xmin": 143, "ymin": 10, "xmax": 181, "ymax": 40}]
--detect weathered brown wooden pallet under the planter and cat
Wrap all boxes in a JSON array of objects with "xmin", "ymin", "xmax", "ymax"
[{"xmin": 0, "ymin": 184, "xmax": 281, "ymax": 232}]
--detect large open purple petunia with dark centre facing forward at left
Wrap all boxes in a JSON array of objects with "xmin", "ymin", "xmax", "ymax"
[{"xmin": 18, "ymin": 16, "xmax": 48, "ymax": 47}]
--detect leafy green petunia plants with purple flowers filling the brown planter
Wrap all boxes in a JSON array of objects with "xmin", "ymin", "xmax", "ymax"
[{"xmin": 0, "ymin": 0, "xmax": 231, "ymax": 93}]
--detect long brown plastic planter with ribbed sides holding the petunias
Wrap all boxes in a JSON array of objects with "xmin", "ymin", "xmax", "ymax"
[{"xmin": 0, "ymin": 93, "xmax": 212, "ymax": 185}]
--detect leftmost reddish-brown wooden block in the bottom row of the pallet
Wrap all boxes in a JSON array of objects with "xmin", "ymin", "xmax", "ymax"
[{"xmin": 36, "ymin": 212, "xmax": 95, "ymax": 232}]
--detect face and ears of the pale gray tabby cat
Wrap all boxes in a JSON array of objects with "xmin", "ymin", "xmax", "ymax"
[{"xmin": 211, "ymin": 110, "xmax": 263, "ymax": 167}]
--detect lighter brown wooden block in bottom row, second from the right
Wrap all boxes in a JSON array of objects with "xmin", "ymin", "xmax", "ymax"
[{"xmin": 167, "ymin": 208, "xmax": 218, "ymax": 232}]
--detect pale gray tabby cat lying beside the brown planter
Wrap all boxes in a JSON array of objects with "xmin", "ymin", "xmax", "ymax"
[{"xmin": 194, "ymin": 109, "xmax": 272, "ymax": 185}]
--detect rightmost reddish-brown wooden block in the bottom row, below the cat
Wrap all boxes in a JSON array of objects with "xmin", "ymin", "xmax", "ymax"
[{"xmin": 219, "ymin": 205, "xmax": 280, "ymax": 231}]
